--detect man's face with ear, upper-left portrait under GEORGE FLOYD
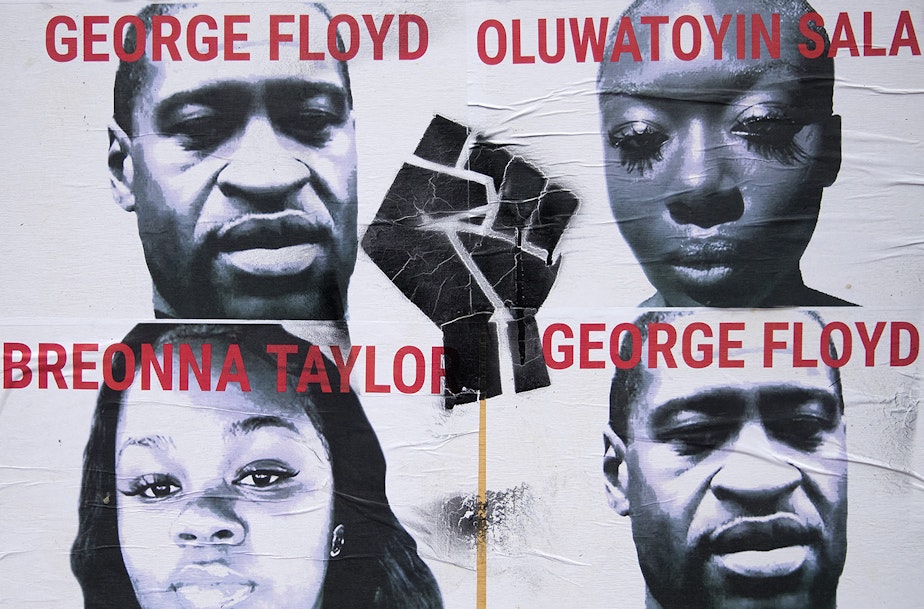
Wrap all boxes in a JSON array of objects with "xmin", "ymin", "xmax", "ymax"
[{"xmin": 110, "ymin": 5, "xmax": 357, "ymax": 319}]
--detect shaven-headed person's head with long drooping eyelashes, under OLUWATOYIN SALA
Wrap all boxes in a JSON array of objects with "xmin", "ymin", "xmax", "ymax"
[{"xmin": 599, "ymin": 0, "xmax": 844, "ymax": 307}]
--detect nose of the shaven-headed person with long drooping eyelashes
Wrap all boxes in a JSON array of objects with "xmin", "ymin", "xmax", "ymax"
[{"xmin": 667, "ymin": 120, "xmax": 744, "ymax": 228}]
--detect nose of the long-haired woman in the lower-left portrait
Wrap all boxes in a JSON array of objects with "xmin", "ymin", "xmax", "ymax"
[{"xmin": 171, "ymin": 495, "xmax": 247, "ymax": 547}]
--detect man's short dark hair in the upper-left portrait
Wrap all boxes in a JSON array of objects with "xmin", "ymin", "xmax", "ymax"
[{"xmin": 112, "ymin": 2, "xmax": 353, "ymax": 136}]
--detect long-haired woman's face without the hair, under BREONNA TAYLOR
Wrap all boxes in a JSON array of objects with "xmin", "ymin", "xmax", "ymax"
[{"xmin": 115, "ymin": 352, "xmax": 333, "ymax": 609}]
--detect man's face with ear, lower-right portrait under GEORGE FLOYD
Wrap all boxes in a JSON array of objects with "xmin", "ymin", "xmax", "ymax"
[{"xmin": 604, "ymin": 320, "xmax": 847, "ymax": 609}]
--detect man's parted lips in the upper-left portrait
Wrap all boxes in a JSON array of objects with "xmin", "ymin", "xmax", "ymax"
[{"xmin": 215, "ymin": 211, "xmax": 332, "ymax": 277}]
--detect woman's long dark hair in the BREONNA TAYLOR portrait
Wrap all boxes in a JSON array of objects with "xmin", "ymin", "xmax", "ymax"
[{"xmin": 71, "ymin": 323, "xmax": 442, "ymax": 609}]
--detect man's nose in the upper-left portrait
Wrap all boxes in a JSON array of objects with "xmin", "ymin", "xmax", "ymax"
[{"xmin": 217, "ymin": 116, "xmax": 311, "ymax": 205}]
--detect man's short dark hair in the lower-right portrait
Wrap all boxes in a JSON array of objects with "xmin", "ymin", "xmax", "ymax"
[{"xmin": 609, "ymin": 310, "xmax": 844, "ymax": 444}]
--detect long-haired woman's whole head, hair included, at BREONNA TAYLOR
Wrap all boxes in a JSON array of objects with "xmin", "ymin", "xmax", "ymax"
[{"xmin": 71, "ymin": 324, "xmax": 442, "ymax": 609}]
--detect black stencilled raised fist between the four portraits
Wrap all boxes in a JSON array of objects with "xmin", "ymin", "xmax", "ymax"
[{"xmin": 362, "ymin": 116, "xmax": 578, "ymax": 408}]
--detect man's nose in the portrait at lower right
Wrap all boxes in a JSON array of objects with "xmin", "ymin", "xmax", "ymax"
[{"xmin": 711, "ymin": 422, "xmax": 802, "ymax": 506}]
